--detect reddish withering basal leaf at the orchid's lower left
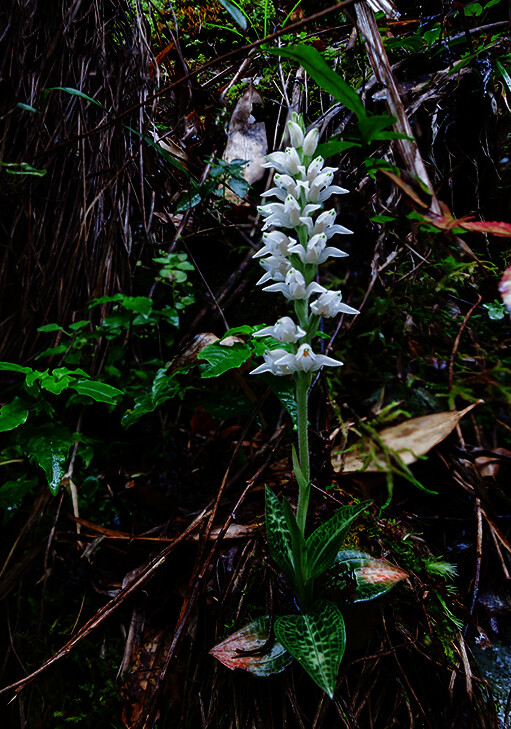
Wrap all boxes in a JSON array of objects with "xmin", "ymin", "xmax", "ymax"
[{"xmin": 209, "ymin": 615, "xmax": 293, "ymax": 676}]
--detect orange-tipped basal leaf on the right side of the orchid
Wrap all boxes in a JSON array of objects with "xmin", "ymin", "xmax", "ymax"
[{"xmin": 332, "ymin": 549, "xmax": 408, "ymax": 602}]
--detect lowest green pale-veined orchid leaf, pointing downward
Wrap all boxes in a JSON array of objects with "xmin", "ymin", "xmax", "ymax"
[{"xmin": 275, "ymin": 600, "xmax": 346, "ymax": 699}]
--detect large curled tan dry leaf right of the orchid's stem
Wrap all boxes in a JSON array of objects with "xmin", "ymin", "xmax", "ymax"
[{"xmin": 332, "ymin": 401, "xmax": 480, "ymax": 473}]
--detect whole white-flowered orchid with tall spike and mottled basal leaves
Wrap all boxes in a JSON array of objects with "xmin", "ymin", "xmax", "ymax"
[{"xmin": 211, "ymin": 114, "xmax": 406, "ymax": 698}]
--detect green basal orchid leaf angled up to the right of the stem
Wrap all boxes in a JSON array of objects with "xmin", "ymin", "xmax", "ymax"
[{"xmin": 307, "ymin": 501, "xmax": 371, "ymax": 579}]
